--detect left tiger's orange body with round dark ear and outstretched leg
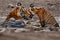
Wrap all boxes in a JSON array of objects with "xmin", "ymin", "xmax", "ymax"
[{"xmin": 2, "ymin": 2, "xmax": 24, "ymax": 25}]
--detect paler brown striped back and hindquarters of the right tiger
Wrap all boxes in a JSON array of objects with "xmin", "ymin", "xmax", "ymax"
[{"xmin": 44, "ymin": 8, "xmax": 59, "ymax": 27}]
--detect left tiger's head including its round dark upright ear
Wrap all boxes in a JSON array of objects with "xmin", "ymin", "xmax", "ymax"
[{"xmin": 17, "ymin": 2, "xmax": 33, "ymax": 20}]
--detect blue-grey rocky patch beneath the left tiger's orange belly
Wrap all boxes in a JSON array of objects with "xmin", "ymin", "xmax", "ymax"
[{"xmin": 6, "ymin": 20, "xmax": 24, "ymax": 28}]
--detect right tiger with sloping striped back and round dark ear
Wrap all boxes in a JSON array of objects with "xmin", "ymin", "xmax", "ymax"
[{"xmin": 24, "ymin": 4, "xmax": 59, "ymax": 30}]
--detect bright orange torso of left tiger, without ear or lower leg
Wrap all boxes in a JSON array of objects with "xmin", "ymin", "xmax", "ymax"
[{"xmin": 6, "ymin": 6, "xmax": 22, "ymax": 20}]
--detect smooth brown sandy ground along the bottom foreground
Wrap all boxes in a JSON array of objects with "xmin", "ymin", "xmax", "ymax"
[{"xmin": 0, "ymin": 32, "xmax": 60, "ymax": 40}]
